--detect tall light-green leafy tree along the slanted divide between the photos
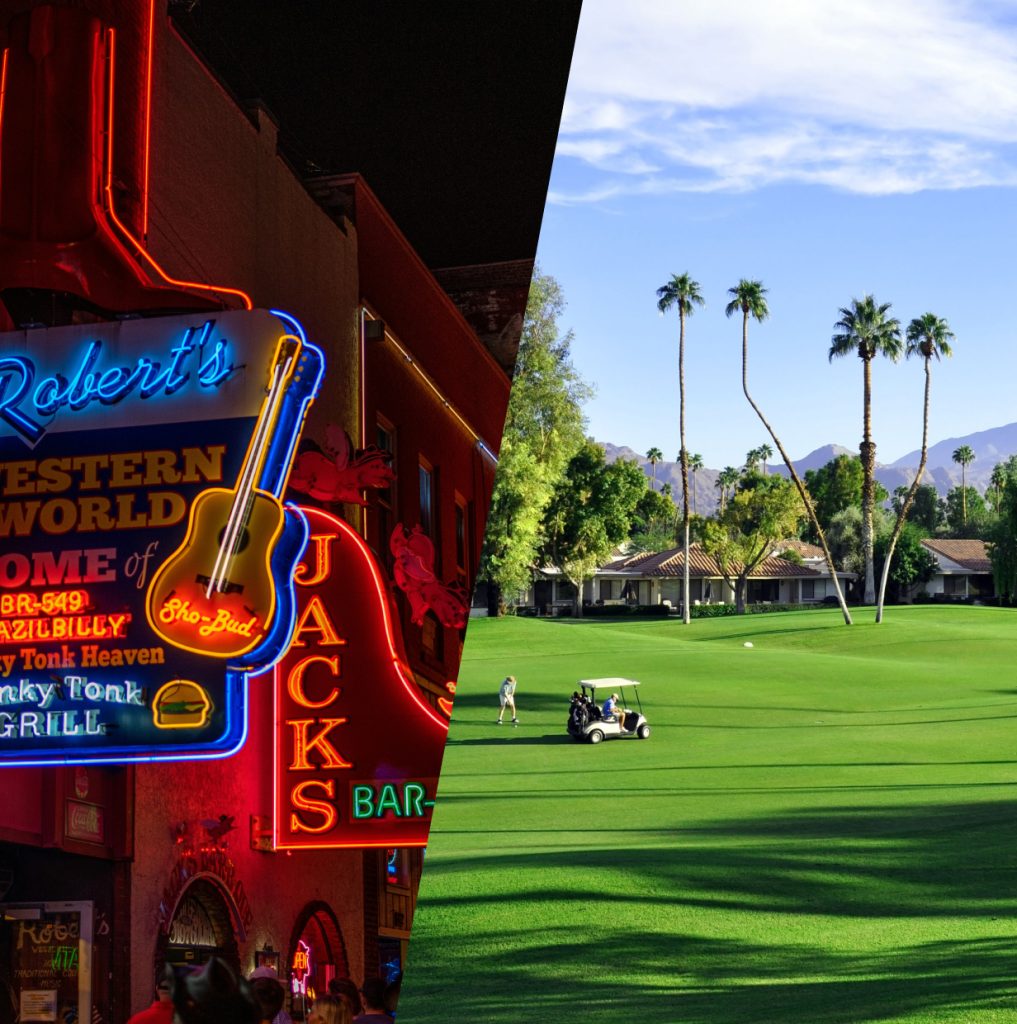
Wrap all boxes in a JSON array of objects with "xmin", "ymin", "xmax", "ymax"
[{"xmin": 478, "ymin": 270, "xmax": 592, "ymax": 613}]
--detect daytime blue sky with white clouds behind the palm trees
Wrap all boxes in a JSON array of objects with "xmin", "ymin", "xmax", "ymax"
[{"xmin": 539, "ymin": 0, "xmax": 1017, "ymax": 468}]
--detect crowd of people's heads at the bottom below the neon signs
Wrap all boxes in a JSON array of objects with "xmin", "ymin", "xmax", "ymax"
[{"xmin": 127, "ymin": 956, "xmax": 398, "ymax": 1024}]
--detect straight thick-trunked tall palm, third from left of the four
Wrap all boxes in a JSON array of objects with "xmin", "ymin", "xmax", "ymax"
[{"xmin": 830, "ymin": 295, "xmax": 903, "ymax": 604}]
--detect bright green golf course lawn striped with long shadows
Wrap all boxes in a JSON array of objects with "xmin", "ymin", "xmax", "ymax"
[{"xmin": 399, "ymin": 607, "xmax": 1017, "ymax": 1024}]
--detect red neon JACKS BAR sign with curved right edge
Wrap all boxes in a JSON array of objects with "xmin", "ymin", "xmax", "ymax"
[{"xmin": 273, "ymin": 508, "xmax": 448, "ymax": 849}]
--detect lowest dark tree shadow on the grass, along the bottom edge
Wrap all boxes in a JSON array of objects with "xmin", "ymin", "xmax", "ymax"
[{"xmin": 400, "ymin": 925, "xmax": 1017, "ymax": 1024}]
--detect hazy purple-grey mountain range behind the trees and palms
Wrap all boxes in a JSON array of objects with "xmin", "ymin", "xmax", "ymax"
[{"xmin": 598, "ymin": 423, "xmax": 1017, "ymax": 515}]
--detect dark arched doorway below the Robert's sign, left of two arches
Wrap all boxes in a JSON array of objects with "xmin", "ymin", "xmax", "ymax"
[{"xmin": 156, "ymin": 876, "xmax": 244, "ymax": 973}]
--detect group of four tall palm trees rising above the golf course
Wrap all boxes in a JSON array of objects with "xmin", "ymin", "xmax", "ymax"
[{"xmin": 647, "ymin": 272, "xmax": 950, "ymax": 626}]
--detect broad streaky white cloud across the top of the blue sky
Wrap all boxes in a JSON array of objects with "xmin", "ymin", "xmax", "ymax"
[{"xmin": 549, "ymin": 0, "xmax": 1017, "ymax": 202}]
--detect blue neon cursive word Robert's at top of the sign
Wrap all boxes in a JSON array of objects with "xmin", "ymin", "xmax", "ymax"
[{"xmin": 0, "ymin": 321, "xmax": 234, "ymax": 444}]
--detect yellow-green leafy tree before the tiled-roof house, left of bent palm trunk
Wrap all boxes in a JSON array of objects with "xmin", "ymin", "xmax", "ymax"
[{"xmin": 704, "ymin": 476, "xmax": 805, "ymax": 614}]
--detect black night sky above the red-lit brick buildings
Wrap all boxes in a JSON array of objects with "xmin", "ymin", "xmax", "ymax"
[{"xmin": 171, "ymin": 0, "xmax": 581, "ymax": 267}]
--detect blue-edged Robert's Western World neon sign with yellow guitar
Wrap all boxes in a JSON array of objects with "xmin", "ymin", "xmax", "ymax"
[{"xmin": 0, "ymin": 310, "xmax": 325, "ymax": 766}]
